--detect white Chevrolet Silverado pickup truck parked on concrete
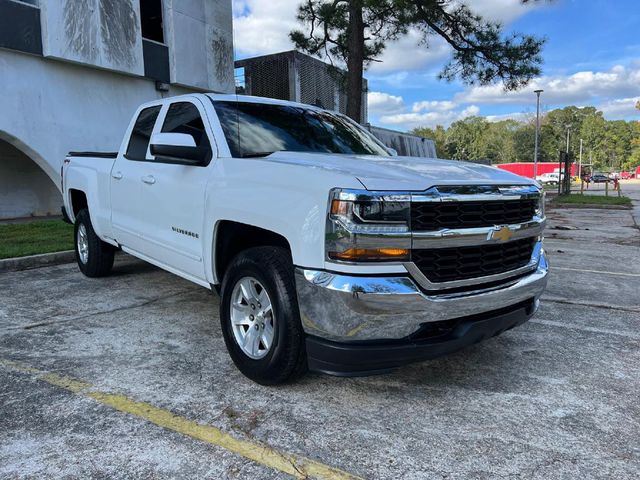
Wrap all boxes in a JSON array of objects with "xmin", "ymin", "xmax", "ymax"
[{"xmin": 62, "ymin": 94, "xmax": 548, "ymax": 384}]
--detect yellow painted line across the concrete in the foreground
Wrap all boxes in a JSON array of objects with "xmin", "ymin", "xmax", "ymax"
[{"xmin": 0, "ymin": 359, "xmax": 360, "ymax": 480}]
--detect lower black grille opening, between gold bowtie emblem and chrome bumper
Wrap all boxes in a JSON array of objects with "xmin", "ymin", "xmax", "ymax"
[{"xmin": 411, "ymin": 238, "xmax": 536, "ymax": 283}]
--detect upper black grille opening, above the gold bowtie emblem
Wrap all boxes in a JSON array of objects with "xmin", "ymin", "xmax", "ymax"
[{"xmin": 411, "ymin": 198, "xmax": 538, "ymax": 232}]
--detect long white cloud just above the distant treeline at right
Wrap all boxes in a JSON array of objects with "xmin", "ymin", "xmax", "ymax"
[{"xmin": 454, "ymin": 65, "xmax": 640, "ymax": 105}]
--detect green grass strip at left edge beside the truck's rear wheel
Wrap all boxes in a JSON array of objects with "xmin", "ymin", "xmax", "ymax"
[{"xmin": 0, "ymin": 220, "xmax": 73, "ymax": 259}]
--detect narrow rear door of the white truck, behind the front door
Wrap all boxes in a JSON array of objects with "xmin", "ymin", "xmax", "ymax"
[{"xmin": 111, "ymin": 105, "xmax": 162, "ymax": 252}]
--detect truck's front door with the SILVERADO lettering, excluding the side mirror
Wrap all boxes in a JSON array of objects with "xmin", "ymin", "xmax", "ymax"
[{"xmin": 134, "ymin": 97, "xmax": 214, "ymax": 280}]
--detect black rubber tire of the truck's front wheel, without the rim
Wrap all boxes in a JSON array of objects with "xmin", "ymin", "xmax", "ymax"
[{"xmin": 220, "ymin": 247, "xmax": 307, "ymax": 385}]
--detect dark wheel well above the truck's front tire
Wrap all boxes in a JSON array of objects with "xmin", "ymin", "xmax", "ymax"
[{"xmin": 214, "ymin": 220, "xmax": 291, "ymax": 282}]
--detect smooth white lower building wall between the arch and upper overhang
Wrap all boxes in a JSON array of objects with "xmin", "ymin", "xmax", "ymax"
[{"xmin": 0, "ymin": 47, "xmax": 192, "ymax": 184}]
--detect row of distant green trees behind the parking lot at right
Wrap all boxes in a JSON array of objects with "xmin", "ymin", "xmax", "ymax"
[{"xmin": 412, "ymin": 106, "xmax": 640, "ymax": 171}]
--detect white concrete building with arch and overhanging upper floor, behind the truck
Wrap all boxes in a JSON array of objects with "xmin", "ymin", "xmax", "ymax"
[{"xmin": 0, "ymin": 0, "xmax": 234, "ymax": 218}]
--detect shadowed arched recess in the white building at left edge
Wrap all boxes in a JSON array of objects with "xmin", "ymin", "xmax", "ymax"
[{"xmin": 0, "ymin": 140, "xmax": 62, "ymax": 218}]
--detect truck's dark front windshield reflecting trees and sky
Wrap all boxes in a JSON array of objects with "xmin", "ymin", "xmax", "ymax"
[{"xmin": 213, "ymin": 101, "xmax": 389, "ymax": 157}]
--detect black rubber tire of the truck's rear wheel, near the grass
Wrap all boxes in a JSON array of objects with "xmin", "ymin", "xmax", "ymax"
[{"xmin": 74, "ymin": 208, "xmax": 116, "ymax": 278}]
